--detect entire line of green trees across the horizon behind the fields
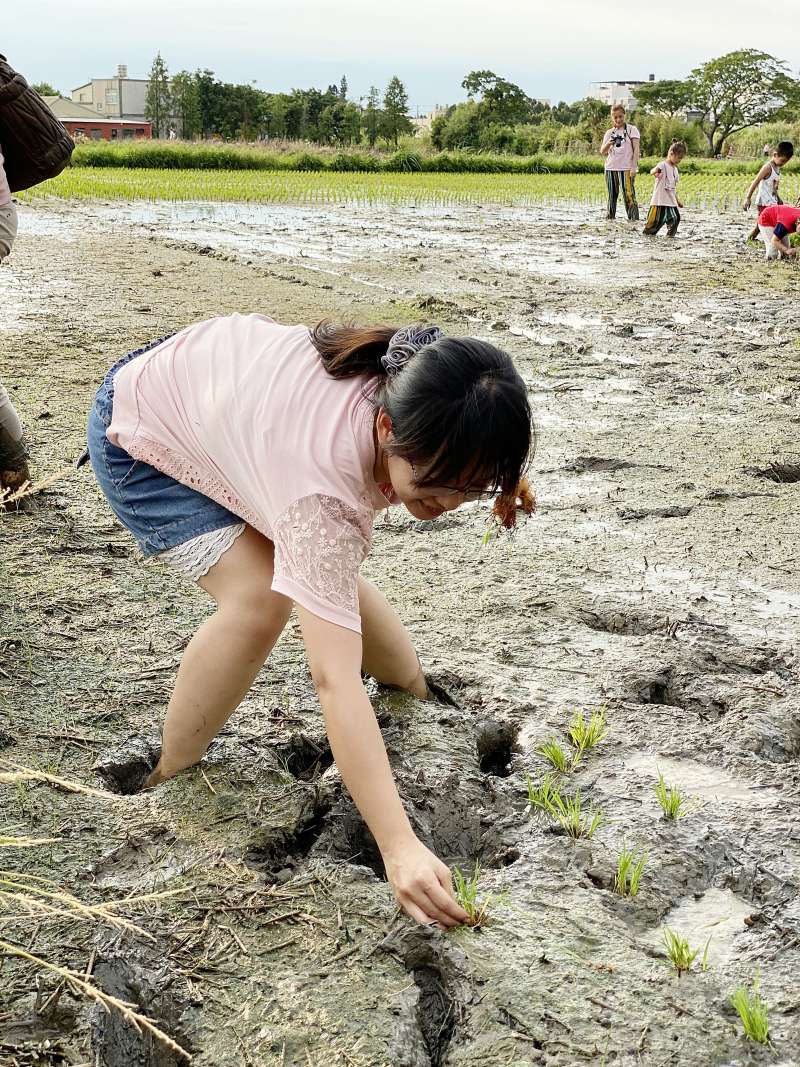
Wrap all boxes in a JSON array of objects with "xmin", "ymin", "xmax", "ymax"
[{"xmin": 136, "ymin": 49, "xmax": 800, "ymax": 156}]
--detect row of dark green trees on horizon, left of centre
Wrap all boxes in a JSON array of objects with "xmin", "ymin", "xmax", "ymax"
[{"xmin": 145, "ymin": 52, "xmax": 414, "ymax": 146}]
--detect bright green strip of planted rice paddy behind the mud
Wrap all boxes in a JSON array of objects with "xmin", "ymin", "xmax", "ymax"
[{"xmin": 21, "ymin": 166, "xmax": 800, "ymax": 211}]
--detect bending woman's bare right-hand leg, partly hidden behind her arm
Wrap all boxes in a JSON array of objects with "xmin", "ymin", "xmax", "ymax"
[{"xmin": 358, "ymin": 578, "xmax": 428, "ymax": 700}]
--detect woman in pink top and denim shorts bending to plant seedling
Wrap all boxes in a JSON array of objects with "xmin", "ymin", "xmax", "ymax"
[{"xmin": 87, "ymin": 315, "xmax": 532, "ymax": 926}]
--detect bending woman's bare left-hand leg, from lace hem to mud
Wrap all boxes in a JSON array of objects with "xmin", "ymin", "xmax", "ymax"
[{"xmin": 145, "ymin": 526, "xmax": 292, "ymax": 785}]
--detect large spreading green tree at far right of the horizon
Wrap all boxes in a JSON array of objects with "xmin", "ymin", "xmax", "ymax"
[{"xmin": 688, "ymin": 48, "xmax": 799, "ymax": 156}]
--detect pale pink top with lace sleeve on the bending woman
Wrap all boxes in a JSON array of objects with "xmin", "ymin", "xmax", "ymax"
[{"xmin": 108, "ymin": 315, "xmax": 394, "ymax": 633}]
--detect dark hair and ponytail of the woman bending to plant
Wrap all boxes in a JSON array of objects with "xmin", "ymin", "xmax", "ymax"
[{"xmin": 310, "ymin": 321, "xmax": 534, "ymax": 495}]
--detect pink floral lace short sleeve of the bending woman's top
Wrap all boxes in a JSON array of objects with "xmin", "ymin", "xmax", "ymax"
[{"xmin": 272, "ymin": 494, "xmax": 372, "ymax": 633}]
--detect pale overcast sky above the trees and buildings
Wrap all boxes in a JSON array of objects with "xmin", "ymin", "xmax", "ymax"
[{"xmin": 7, "ymin": 0, "xmax": 800, "ymax": 111}]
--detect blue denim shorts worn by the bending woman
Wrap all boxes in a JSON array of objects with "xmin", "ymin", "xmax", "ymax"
[{"xmin": 85, "ymin": 337, "xmax": 241, "ymax": 556}]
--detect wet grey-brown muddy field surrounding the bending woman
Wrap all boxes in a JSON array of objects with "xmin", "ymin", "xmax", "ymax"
[{"xmin": 0, "ymin": 204, "xmax": 800, "ymax": 1067}]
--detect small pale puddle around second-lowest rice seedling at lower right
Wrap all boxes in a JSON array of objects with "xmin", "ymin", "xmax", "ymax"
[{"xmin": 644, "ymin": 889, "xmax": 753, "ymax": 967}]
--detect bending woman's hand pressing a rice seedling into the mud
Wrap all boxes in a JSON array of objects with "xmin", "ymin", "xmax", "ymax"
[{"xmin": 383, "ymin": 834, "xmax": 469, "ymax": 929}]
